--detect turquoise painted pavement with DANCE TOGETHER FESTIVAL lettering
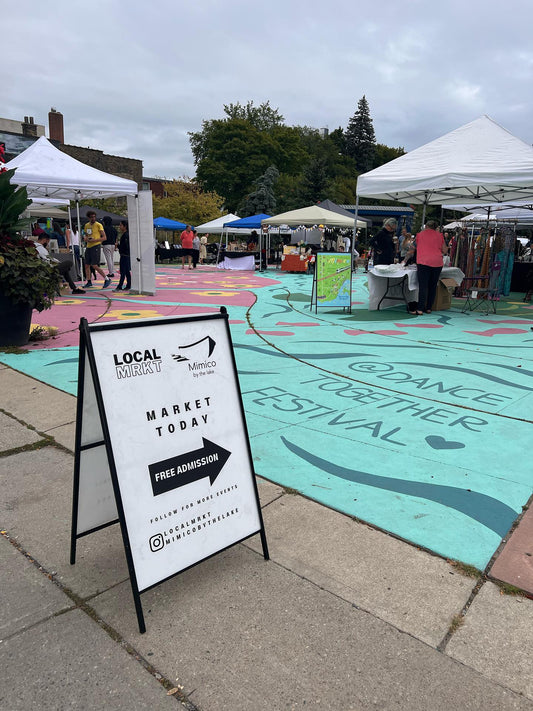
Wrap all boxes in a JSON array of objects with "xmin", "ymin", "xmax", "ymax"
[{"xmin": 0, "ymin": 271, "xmax": 533, "ymax": 569}]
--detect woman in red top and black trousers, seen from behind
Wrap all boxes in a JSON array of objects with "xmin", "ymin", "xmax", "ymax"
[{"xmin": 415, "ymin": 220, "xmax": 448, "ymax": 316}]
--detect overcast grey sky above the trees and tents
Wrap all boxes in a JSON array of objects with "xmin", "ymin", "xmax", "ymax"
[{"xmin": 4, "ymin": 0, "xmax": 533, "ymax": 178}]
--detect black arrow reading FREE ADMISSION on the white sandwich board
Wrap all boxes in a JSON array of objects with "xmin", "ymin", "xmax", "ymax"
[{"xmin": 148, "ymin": 437, "xmax": 231, "ymax": 496}]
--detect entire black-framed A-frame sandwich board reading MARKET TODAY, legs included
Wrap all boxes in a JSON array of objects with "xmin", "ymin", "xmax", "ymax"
[{"xmin": 71, "ymin": 308, "xmax": 268, "ymax": 632}]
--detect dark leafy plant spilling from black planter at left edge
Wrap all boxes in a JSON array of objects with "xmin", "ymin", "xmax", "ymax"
[{"xmin": 0, "ymin": 170, "xmax": 61, "ymax": 311}]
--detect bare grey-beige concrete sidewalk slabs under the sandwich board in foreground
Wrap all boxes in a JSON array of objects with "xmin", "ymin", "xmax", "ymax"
[{"xmin": 0, "ymin": 366, "xmax": 533, "ymax": 711}]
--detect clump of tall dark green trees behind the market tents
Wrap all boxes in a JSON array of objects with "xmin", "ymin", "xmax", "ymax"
[{"xmin": 189, "ymin": 96, "xmax": 403, "ymax": 213}]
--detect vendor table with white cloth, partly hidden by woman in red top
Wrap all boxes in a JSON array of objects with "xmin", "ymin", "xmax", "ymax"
[{"xmin": 368, "ymin": 264, "xmax": 465, "ymax": 311}]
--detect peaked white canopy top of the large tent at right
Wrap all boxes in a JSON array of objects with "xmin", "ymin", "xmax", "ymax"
[{"xmin": 357, "ymin": 116, "xmax": 533, "ymax": 205}]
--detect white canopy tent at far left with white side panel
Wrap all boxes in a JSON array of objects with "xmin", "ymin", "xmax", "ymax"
[{"xmin": 5, "ymin": 136, "xmax": 155, "ymax": 293}]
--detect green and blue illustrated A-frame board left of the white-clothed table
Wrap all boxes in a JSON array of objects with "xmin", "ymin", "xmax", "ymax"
[{"xmin": 312, "ymin": 252, "xmax": 352, "ymax": 311}]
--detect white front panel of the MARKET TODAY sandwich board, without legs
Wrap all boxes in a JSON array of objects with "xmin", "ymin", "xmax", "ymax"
[{"xmin": 85, "ymin": 317, "xmax": 261, "ymax": 592}]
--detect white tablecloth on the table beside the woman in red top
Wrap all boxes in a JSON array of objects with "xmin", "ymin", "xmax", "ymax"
[{"xmin": 368, "ymin": 266, "xmax": 465, "ymax": 311}]
